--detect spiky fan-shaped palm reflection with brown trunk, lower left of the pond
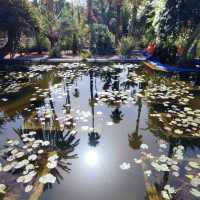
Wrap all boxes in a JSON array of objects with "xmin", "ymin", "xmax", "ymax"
[{"xmin": 8, "ymin": 102, "xmax": 80, "ymax": 200}]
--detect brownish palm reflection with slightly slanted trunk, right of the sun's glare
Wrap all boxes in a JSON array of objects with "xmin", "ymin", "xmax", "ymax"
[{"xmin": 128, "ymin": 97, "xmax": 142, "ymax": 149}]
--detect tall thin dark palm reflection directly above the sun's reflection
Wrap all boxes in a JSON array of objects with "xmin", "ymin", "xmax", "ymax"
[{"xmin": 88, "ymin": 70, "xmax": 101, "ymax": 147}]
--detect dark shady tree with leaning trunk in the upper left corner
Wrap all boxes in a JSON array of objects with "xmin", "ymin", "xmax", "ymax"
[{"xmin": 0, "ymin": 0, "xmax": 41, "ymax": 59}]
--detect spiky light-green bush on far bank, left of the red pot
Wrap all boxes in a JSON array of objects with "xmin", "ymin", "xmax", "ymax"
[{"xmin": 117, "ymin": 36, "xmax": 135, "ymax": 56}]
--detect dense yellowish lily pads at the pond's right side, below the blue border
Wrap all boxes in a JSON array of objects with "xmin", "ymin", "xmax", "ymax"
[{"xmin": 146, "ymin": 82, "xmax": 200, "ymax": 137}]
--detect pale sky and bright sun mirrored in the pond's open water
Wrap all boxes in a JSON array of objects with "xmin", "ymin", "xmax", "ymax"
[{"xmin": 1, "ymin": 66, "xmax": 200, "ymax": 200}]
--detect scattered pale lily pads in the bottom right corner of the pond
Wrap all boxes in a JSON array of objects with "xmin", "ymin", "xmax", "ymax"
[{"xmin": 120, "ymin": 141, "xmax": 200, "ymax": 200}]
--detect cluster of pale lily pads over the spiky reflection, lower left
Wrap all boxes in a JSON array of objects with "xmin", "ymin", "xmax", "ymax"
[{"xmin": 0, "ymin": 131, "xmax": 63, "ymax": 193}]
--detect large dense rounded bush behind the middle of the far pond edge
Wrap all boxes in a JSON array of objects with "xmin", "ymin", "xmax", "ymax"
[{"xmin": 90, "ymin": 24, "xmax": 114, "ymax": 55}]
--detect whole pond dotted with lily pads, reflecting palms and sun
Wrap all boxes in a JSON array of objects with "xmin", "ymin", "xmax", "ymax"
[{"xmin": 0, "ymin": 63, "xmax": 200, "ymax": 200}]
